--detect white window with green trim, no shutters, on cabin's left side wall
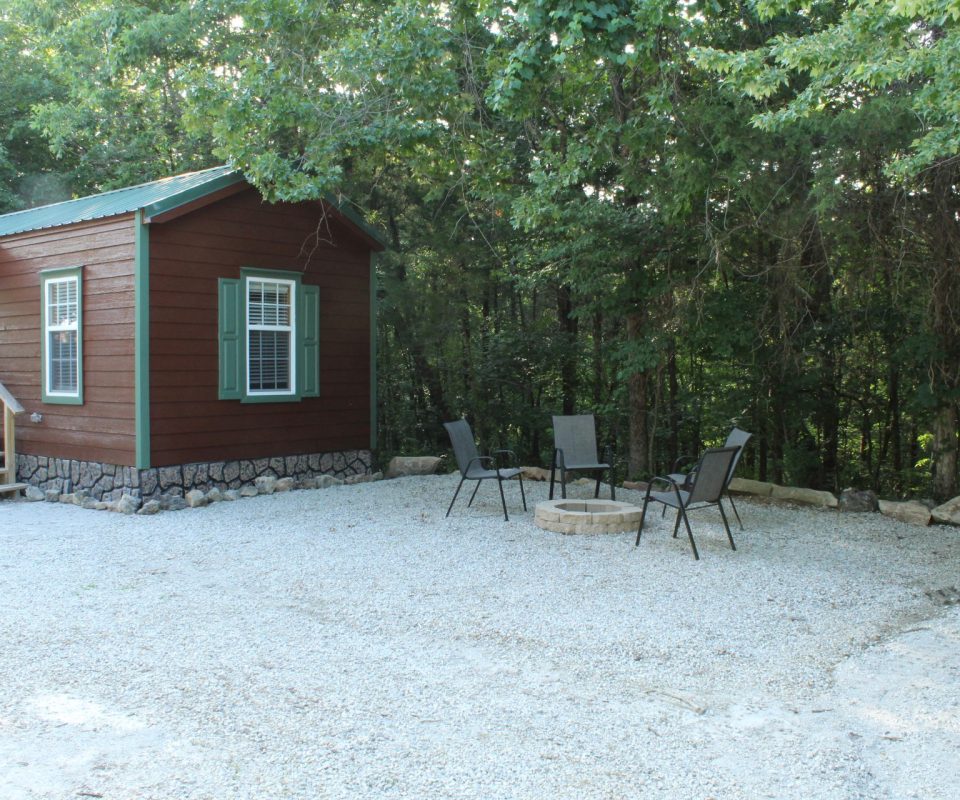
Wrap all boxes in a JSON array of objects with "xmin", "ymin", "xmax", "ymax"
[{"xmin": 40, "ymin": 267, "xmax": 83, "ymax": 404}]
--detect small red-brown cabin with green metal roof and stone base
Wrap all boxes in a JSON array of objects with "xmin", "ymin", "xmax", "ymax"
[{"xmin": 0, "ymin": 167, "xmax": 384, "ymax": 501}]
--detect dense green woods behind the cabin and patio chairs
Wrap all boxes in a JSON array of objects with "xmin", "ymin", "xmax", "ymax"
[{"xmin": 0, "ymin": 0, "xmax": 960, "ymax": 499}]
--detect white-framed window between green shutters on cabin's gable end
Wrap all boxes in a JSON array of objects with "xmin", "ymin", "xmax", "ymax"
[{"xmin": 246, "ymin": 276, "xmax": 297, "ymax": 396}]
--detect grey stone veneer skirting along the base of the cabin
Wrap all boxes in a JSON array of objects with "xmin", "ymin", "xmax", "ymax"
[{"xmin": 17, "ymin": 450, "xmax": 373, "ymax": 502}]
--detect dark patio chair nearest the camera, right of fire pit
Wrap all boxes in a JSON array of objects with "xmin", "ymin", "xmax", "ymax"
[{"xmin": 636, "ymin": 447, "xmax": 741, "ymax": 561}]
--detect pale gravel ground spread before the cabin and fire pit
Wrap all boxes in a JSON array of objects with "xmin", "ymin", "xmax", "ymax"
[{"xmin": 0, "ymin": 476, "xmax": 960, "ymax": 800}]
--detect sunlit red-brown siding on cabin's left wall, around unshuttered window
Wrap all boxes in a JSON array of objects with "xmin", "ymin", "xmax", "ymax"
[{"xmin": 0, "ymin": 214, "xmax": 135, "ymax": 466}]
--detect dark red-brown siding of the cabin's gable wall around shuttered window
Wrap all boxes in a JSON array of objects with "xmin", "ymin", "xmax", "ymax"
[{"xmin": 150, "ymin": 190, "xmax": 370, "ymax": 466}]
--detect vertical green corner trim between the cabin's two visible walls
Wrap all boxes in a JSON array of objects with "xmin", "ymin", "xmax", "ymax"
[{"xmin": 133, "ymin": 210, "xmax": 150, "ymax": 469}]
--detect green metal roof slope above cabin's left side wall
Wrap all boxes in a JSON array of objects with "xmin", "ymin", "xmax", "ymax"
[{"xmin": 0, "ymin": 166, "xmax": 243, "ymax": 236}]
